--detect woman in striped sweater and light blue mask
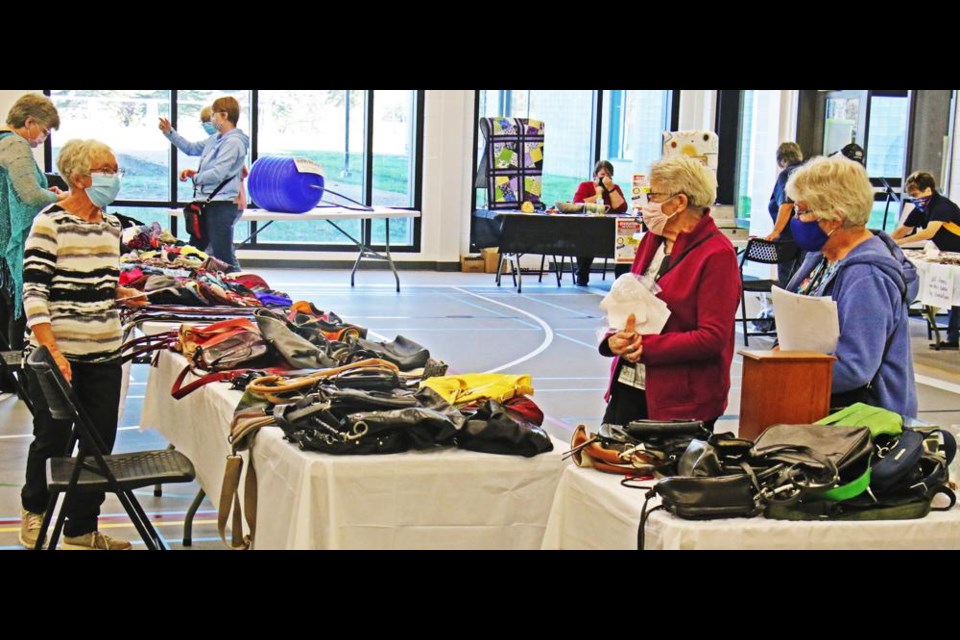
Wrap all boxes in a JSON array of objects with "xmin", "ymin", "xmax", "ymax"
[{"xmin": 20, "ymin": 140, "xmax": 142, "ymax": 549}]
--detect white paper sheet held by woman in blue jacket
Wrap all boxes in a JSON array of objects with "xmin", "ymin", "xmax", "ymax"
[{"xmin": 772, "ymin": 287, "xmax": 840, "ymax": 354}]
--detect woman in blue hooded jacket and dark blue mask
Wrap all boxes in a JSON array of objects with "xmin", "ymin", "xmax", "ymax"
[{"xmin": 787, "ymin": 156, "xmax": 917, "ymax": 416}]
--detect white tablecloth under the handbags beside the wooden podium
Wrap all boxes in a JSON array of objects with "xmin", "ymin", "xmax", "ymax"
[{"xmin": 542, "ymin": 466, "xmax": 960, "ymax": 549}]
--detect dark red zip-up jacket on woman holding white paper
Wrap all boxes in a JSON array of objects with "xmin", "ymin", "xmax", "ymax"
[{"xmin": 600, "ymin": 213, "xmax": 740, "ymax": 420}]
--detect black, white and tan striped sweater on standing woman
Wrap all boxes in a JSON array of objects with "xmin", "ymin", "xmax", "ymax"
[{"xmin": 23, "ymin": 205, "xmax": 121, "ymax": 362}]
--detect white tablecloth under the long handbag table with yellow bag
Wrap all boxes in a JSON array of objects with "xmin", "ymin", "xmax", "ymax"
[{"xmin": 141, "ymin": 352, "xmax": 567, "ymax": 549}]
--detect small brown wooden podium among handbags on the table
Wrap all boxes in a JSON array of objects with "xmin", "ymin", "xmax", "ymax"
[{"xmin": 737, "ymin": 349, "xmax": 834, "ymax": 440}]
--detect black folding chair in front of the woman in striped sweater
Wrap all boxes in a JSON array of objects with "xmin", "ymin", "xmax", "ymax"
[{"xmin": 27, "ymin": 347, "xmax": 196, "ymax": 550}]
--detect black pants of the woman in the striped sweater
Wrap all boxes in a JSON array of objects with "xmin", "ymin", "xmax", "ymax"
[{"xmin": 20, "ymin": 361, "xmax": 122, "ymax": 537}]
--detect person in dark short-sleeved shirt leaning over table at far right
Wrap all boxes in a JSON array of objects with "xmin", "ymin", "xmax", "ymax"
[{"xmin": 892, "ymin": 171, "xmax": 960, "ymax": 349}]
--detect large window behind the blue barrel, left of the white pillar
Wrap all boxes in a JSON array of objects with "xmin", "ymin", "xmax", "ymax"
[{"xmin": 41, "ymin": 89, "xmax": 423, "ymax": 251}]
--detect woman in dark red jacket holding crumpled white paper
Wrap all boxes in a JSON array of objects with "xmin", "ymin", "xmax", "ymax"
[{"xmin": 600, "ymin": 156, "xmax": 740, "ymax": 430}]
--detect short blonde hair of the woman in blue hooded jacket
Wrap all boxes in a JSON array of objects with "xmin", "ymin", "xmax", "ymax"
[{"xmin": 787, "ymin": 155, "xmax": 873, "ymax": 228}]
